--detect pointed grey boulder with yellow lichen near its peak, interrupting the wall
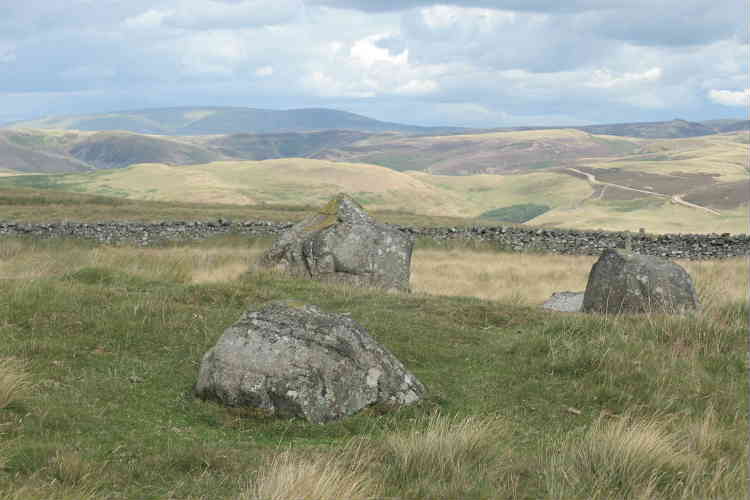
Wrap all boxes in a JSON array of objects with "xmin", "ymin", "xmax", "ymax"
[{"xmin": 259, "ymin": 194, "xmax": 414, "ymax": 290}]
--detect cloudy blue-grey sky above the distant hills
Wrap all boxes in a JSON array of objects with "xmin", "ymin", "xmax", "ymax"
[{"xmin": 0, "ymin": 0, "xmax": 750, "ymax": 127}]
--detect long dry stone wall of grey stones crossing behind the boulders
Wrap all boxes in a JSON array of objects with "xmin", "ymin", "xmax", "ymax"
[{"xmin": 0, "ymin": 219, "xmax": 750, "ymax": 259}]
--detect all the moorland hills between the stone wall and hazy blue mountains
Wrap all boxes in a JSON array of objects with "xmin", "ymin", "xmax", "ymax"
[{"xmin": 0, "ymin": 129, "xmax": 750, "ymax": 233}]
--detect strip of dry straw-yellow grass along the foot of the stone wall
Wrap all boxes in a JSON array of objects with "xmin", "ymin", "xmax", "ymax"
[{"xmin": 0, "ymin": 238, "xmax": 748, "ymax": 306}]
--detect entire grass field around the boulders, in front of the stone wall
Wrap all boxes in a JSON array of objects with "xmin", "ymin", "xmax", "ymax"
[{"xmin": 0, "ymin": 237, "xmax": 748, "ymax": 500}]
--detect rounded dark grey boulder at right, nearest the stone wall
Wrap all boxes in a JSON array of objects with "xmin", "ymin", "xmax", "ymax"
[{"xmin": 583, "ymin": 249, "xmax": 699, "ymax": 314}]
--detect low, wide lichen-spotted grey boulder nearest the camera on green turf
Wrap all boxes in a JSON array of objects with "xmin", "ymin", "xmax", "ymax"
[{"xmin": 195, "ymin": 301, "xmax": 425, "ymax": 423}]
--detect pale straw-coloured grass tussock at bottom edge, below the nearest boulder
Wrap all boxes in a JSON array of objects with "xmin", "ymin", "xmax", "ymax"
[{"xmin": 238, "ymin": 442, "xmax": 382, "ymax": 500}]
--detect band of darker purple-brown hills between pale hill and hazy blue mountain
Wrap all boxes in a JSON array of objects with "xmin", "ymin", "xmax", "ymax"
[{"xmin": 0, "ymin": 129, "xmax": 645, "ymax": 175}]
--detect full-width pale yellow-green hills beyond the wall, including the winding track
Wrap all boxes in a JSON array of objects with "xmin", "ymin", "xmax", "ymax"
[{"xmin": 0, "ymin": 144, "xmax": 750, "ymax": 233}]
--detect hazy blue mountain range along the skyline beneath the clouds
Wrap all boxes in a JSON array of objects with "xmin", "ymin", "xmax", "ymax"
[{"xmin": 4, "ymin": 107, "xmax": 750, "ymax": 139}]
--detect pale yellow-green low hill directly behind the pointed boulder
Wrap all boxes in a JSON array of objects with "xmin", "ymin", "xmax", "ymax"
[{"xmin": 0, "ymin": 159, "xmax": 591, "ymax": 217}]
